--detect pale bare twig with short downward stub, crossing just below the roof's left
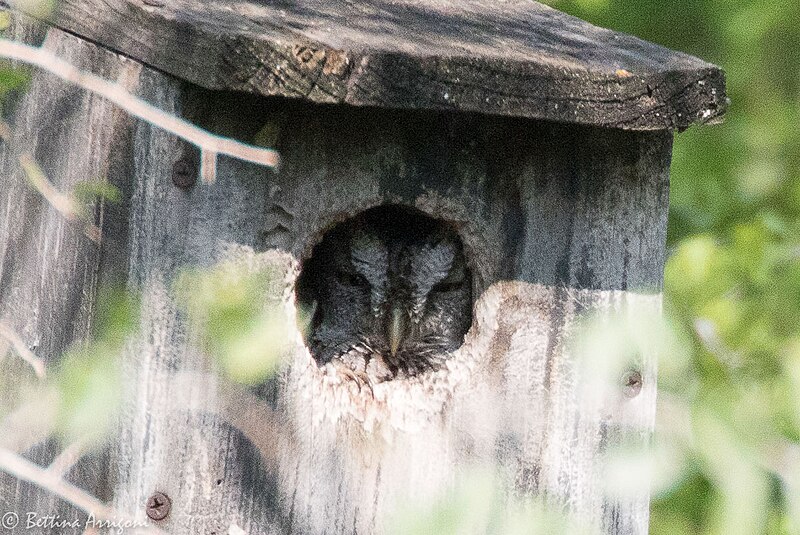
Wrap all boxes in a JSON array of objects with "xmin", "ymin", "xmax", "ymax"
[{"xmin": 0, "ymin": 39, "xmax": 280, "ymax": 182}]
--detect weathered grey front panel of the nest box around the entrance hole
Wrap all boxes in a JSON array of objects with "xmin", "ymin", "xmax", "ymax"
[{"xmin": 103, "ymin": 85, "xmax": 671, "ymax": 533}]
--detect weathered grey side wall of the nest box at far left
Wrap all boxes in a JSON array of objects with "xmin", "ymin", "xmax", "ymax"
[{"xmin": 0, "ymin": 18, "xmax": 141, "ymax": 533}]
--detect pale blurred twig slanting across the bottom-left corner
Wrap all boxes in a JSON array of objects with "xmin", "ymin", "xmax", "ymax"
[{"xmin": 0, "ymin": 449, "xmax": 164, "ymax": 534}]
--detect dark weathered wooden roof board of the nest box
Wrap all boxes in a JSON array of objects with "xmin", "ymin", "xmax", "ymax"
[{"xmin": 20, "ymin": 0, "xmax": 727, "ymax": 130}]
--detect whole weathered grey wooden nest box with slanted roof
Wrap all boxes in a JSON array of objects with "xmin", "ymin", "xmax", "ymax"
[{"xmin": 0, "ymin": 0, "xmax": 726, "ymax": 535}]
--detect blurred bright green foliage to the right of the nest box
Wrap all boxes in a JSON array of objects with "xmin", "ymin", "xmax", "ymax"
[{"xmin": 549, "ymin": 0, "xmax": 800, "ymax": 534}]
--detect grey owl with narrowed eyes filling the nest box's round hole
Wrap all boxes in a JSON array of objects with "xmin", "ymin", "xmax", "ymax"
[{"xmin": 298, "ymin": 206, "xmax": 472, "ymax": 386}]
